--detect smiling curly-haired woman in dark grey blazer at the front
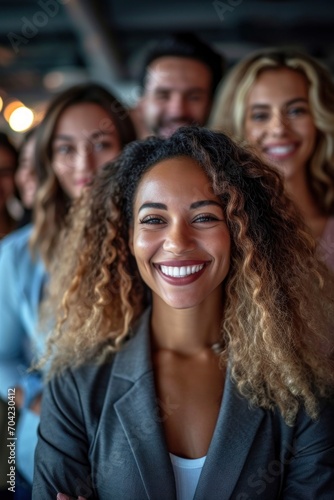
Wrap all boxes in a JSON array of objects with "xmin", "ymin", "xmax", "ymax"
[{"xmin": 34, "ymin": 127, "xmax": 334, "ymax": 500}]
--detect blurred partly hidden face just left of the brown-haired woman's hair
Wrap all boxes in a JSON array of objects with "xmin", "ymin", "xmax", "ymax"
[{"xmin": 15, "ymin": 135, "xmax": 37, "ymax": 208}]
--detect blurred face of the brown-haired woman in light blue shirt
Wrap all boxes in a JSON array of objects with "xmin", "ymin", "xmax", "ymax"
[{"xmin": 52, "ymin": 103, "xmax": 121, "ymax": 198}]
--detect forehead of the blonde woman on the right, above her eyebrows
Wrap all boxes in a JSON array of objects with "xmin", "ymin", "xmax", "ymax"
[{"xmin": 248, "ymin": 68, "xmax": 308, "ymax": 102}]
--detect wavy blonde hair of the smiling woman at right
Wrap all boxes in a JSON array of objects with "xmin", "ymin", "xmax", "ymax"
[{"xmin": 209, "ymin": 48, "xmax": 334, "ymax": 215}]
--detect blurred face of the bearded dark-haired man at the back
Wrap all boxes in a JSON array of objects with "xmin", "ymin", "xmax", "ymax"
[{"xmin": 141, "ymin": 57, "xmax": 212, "ymax": 137}]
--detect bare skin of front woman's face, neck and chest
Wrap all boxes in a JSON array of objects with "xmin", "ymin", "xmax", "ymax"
[{"xmin": 130, "ymin": 158, "xmax": 230, "ymax": 458}]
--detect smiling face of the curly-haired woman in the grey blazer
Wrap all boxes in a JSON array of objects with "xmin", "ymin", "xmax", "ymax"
[{"xmin": 130, "ymin": 157, "xmax": 230, "ymax": 309}]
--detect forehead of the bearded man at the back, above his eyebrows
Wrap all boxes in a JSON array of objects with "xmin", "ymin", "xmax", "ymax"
[{"xmin": 145, "ymin": 56, "xmax": 212, "ymax": 91}]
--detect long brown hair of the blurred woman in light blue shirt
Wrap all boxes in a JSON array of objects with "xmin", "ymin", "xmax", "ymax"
[{"xmin": 30, "ymin": 83, "xmax": 136, "ymax": 267}]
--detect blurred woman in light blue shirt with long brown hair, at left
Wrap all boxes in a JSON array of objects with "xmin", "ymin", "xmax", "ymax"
[{"xmin": 0, "ymin": 83, "xmax": 135, "ymax": 492}]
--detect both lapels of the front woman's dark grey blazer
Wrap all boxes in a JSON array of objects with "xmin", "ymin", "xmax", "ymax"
[{"xmin": 113, "ymin": 309, "xmax": 265, "ymax": 500}]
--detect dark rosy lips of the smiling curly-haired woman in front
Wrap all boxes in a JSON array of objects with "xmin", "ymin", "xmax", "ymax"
[{"xmin": 153, "ymin": 260, "xmax": 209, "ymax": 286}]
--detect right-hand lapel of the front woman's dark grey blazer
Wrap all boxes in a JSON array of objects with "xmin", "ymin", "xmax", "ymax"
[{"xmin": 194, "ymin": 371, "xmax": 264, "ymax": 500}]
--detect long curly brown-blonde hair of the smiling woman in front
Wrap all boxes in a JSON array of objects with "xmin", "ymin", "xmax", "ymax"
[{"xmin": 44, "ymin": 127, "xmax": 334, "ymax": 423}]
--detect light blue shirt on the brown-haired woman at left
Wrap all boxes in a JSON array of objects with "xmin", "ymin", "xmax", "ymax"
[{"xmin": 0, "ymin": 225, "xmax": 47, "ymax": 482}]
